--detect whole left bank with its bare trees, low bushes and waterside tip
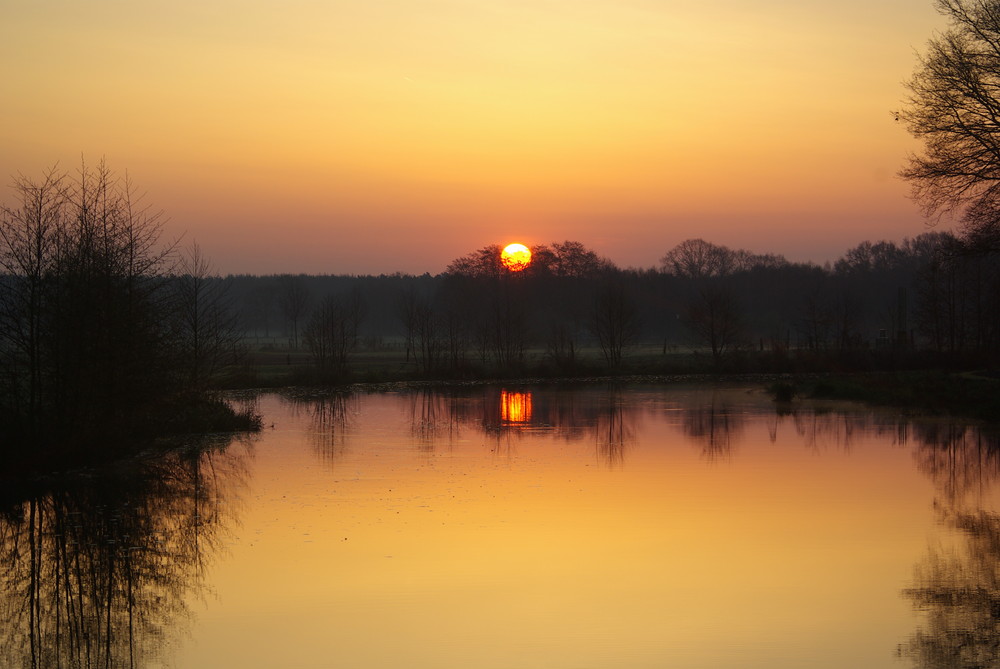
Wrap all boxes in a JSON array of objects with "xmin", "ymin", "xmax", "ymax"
[{"xmin": 0, "ymin": 164, "xmax": 255, "ymax": 474}]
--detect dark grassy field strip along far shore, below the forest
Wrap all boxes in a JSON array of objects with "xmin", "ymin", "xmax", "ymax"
[{"xmin": 222, "ymin": 344, "xmax": 1000, "ymax": 423}]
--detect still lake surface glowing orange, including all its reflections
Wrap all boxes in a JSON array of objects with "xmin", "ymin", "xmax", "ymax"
[{"xmin": 0, "ymin": 386, "xmax": 1000, "ymax": 669}]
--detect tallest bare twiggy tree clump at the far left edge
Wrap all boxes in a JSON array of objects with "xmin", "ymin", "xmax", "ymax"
[{"xmin": 0, "ymin": 163, "xmax": 177, "ymax": 446}]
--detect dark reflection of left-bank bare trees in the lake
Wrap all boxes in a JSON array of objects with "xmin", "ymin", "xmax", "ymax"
[{"xmin": 0, "ymin": 437, "xmax": 249, "ymax": 669}]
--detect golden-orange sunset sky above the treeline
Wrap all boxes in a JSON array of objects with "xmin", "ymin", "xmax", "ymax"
[{"xmin": 0, "ymin": 0, "xmax": 949, "ymax": 274}]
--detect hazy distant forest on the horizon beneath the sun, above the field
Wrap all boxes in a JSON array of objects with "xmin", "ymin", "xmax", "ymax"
[{"xmin": 221, "ymin": 231, "xmax": 1000, "ymax": 376}]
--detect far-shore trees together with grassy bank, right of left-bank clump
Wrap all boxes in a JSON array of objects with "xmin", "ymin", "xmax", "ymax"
[{"xmin": 209, "ymin": 232, "xmax": 1000, "ymax": 421}]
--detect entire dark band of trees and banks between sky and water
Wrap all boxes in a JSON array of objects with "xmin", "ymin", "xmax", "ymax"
[{"xmin": 0, "ymin": 159, "xmax": 1000, "ymax": 478}]
